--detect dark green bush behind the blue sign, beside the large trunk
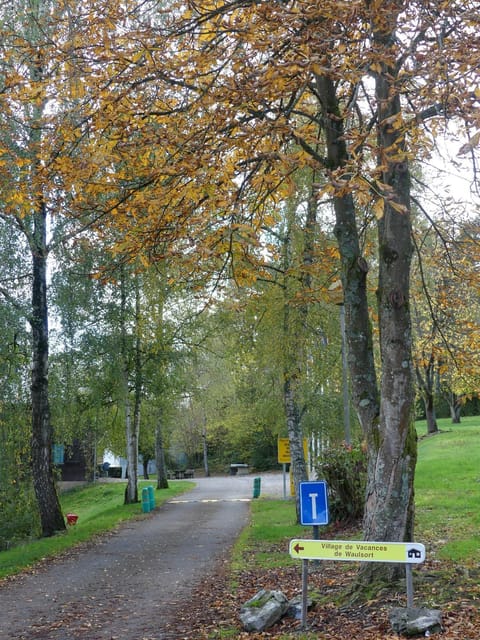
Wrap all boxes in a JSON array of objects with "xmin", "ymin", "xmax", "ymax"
[{"xmin": 315, "ymin": 445, "xmax": 367, "ymax": 522}]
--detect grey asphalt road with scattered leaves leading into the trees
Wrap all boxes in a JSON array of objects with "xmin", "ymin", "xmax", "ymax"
[{"xmin": 0, "ymin": 474, "xmax": 283, "ymax": 640}]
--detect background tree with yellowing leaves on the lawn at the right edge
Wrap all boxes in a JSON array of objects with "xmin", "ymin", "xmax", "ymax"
[{"xmin": 412, "ymin": 217, "xmax": 479, "ymax": 434}]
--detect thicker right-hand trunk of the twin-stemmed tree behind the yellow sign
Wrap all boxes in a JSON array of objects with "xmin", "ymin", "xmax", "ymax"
[{"xmin": 362, "ymin": 3, "xmax": 417, "ymax": 582}]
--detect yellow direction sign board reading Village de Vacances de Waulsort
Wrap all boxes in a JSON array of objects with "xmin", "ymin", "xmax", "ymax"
[{"xmin": 290, "ymin": 539, "xmax": 425, "ymax": 564}]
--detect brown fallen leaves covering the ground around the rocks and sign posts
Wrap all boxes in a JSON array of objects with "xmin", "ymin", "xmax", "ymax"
[{"xmin": 176, "ymin": 544, "xmax": 480, "ymax": 640}]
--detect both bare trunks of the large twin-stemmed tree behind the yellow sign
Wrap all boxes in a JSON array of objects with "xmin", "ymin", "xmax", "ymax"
[{"xmin": 317, "ymin": 2, "xmax": 416, "ymax": 586}]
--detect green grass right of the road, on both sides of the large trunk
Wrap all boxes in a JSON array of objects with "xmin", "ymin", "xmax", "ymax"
[{"xmin": 238, "ymin": 416, "xmax": 480, "ymax": 568}]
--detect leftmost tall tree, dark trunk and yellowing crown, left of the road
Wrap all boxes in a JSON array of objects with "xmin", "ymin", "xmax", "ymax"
[{"xmin": 0, "ymin": 0, "xmax": 156, "ymax": 536}]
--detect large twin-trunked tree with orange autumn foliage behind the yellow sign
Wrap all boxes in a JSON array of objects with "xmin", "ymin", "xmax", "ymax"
[{"xmin": 79, "ymin": 0, "xmax": 478, "ymax": 592}]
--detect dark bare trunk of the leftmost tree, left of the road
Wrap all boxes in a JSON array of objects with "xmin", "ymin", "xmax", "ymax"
[{"xmin": 30, "ymin": 199, "xmax": 65, "ymax": 537}]
